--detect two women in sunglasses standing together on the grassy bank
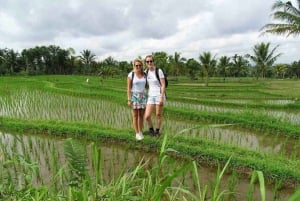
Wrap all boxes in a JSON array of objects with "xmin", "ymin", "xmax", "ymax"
[{"xmin": 127, "ymin": 55, "xmax": 166, "ymax": 140}]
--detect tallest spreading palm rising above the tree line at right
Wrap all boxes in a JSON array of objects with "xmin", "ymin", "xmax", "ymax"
[{"xmin": 246, "ymin": 42, "xmax": 282, "ymax": 78}]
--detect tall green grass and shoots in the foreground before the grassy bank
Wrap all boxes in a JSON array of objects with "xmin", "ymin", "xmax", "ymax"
[{"xmin": 0, "ymin": 130, "xmax": 298, "ymax": 201}]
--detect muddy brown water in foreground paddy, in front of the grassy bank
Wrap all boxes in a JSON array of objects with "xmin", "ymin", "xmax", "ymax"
[{"xmin": 0, "ymin": 131, "xmax": 294, "ymax": 201}]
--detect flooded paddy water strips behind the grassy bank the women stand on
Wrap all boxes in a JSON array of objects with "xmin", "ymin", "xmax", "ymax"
[{"xmin": 0, "ymin": 91, "xmax": 300, "ymax": 159}]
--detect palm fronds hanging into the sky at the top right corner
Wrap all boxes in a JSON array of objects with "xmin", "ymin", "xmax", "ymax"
[{"xmin": 261, "ymin": 0, "xmax": 300, "ymax": 36}]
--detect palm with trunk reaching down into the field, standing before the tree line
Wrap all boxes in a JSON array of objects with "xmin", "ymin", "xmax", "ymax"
[{"xmin": 199, "ymin": 52, "xmax": 217, "ymax": 86}]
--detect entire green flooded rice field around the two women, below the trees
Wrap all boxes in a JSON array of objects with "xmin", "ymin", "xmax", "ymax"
[{"xmin": 0, "ymin": 75, "xmax": 300, "ymax": 200}]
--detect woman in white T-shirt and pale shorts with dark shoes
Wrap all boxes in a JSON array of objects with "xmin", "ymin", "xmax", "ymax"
[{"xmin": 145, "ymin": 55, "xmax": 166, "ymax": 137}]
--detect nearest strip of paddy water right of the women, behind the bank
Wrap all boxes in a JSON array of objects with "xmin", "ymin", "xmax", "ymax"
[{"xmin": 164, "ymin": 120, "xmax": 300, "ymax": 159}]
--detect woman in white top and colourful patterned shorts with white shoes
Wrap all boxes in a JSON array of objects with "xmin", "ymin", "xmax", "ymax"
[{"xmin": 127, "ymin": 59, "xmax": 147, "ymax": 140}]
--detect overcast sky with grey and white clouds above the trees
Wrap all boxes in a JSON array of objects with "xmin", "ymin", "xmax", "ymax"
[{"xmin": 0, "ymin": 0, "xmax": 300, "ymax": 63}]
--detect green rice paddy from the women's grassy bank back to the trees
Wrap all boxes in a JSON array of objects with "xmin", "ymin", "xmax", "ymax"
[{"xmin": 0, "ymin": 76, "xmax": 300, "ymax": 200}]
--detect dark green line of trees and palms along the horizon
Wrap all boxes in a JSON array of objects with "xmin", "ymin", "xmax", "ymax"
[{"xmin": 0, "ymin": 43, "xmax": 300, "ymax": 79}]
